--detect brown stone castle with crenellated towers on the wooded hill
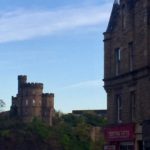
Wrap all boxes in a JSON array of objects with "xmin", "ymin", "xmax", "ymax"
[{"xmin": 11, "ymin": 75, "xmax": 54, "ymax": 126}]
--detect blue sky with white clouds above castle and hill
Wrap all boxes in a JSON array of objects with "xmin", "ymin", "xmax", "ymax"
[{"xmin": 0, "ymin": 0, "xmax": 113, "ymax": 113}]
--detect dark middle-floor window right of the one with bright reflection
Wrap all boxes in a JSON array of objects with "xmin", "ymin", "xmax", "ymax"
[{"xmin": 128, "ymin": 42, "xmax": 134, "ymax": 71}]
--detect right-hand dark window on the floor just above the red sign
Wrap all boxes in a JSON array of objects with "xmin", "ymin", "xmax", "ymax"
[{"xmin": 130, "ymin": 91, "xmax": 136, "ymax": 121}]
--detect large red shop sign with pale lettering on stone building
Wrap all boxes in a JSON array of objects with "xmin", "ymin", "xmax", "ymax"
[{"xmin": 105, "ymin": 124, "xmax": 135, "ymax": 141}]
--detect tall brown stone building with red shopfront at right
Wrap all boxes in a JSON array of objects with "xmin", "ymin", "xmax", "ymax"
[{"xmin": 104, "ymin": 0, "xmax": 150, "ymax": 150}]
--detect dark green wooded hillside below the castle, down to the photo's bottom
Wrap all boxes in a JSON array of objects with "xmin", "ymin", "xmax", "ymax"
[{"xmin": 0, "ymin": 114, "xmax": 105, "ymax": 150}]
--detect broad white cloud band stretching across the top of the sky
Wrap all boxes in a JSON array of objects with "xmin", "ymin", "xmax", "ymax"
[{"xmin": 0, "ymin": 3, "xmax": 111, "ymax": 43}]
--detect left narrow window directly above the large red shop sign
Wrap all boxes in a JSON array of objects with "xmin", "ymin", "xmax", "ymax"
[{"xmin": 116, "ymin": 95, "xmax": 122, "ymax": 123}]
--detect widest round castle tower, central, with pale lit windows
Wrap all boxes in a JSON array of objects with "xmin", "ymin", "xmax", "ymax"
[{"xmin": 19, "ymin": 83, "xmax": 43, "ymax": 122}]
